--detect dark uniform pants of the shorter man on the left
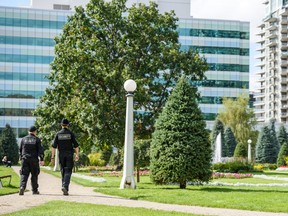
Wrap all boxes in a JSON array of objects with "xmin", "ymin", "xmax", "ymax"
[{"xmin": 20, "ymin": 158, "xmax": 40, "ymax": 192}]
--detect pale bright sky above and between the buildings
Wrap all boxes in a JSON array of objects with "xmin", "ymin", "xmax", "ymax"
[{"xmin": 0, "ymin": 0, "xmax": 265, "ymax": 91}]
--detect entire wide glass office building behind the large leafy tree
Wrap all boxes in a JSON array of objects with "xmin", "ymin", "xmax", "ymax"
[{"xmin": 0, "ymin": 0, "xmax": 249, "ymax": 137}]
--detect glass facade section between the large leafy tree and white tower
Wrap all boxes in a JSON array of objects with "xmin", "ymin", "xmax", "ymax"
[{"xmin": 179, "ymin": 19, "xmax": 250, "ymax": 124}]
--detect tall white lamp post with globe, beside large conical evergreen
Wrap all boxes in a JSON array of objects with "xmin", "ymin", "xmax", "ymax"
[{"xmin": 120, "ymin": 80, "xmax": 137, "ymax": 189}]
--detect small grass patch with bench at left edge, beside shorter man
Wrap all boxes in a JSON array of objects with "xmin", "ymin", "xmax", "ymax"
[{"xmin": 0, "ymin": 166, "xmax": 20, "ymax": 196}]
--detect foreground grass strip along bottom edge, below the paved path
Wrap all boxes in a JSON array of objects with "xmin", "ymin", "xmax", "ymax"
[{"xmin": 4, "ymin": 201, "xmax": 199, "ymax": 216}]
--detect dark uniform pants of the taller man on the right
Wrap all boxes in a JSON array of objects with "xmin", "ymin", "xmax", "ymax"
[{"xmin": 59, "ymin": 152, "xmax": 74, "ymax": 190}]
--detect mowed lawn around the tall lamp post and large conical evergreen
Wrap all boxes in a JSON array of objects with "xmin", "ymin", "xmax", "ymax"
[{"xmin": 41, "ymin": 171, "xmax": 288, "ymax": 213}]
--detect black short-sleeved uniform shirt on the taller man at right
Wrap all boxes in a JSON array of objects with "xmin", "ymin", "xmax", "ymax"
[{"xmin": 52, "ymin": 128, "xmax": 79, "ymax": 153}]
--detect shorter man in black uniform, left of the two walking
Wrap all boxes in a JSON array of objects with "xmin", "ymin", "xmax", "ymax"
[{"xmin": 19, "ymin": 126, "xmax": 44, "ymax": 195}]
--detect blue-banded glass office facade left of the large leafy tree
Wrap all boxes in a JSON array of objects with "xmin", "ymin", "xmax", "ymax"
[{"xmin": 0, "ymin": 7, "xmax": 72, "ymax": 137}]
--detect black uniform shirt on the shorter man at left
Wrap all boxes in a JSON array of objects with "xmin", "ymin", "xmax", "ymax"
[{"xmin": 19, "ymin": 134, "xmax": 44, "ymax": 161}]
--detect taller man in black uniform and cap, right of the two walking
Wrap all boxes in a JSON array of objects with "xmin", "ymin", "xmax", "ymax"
[{"xmin": 51, "ymin": 118, "xmax": 79, "ymax": 196}]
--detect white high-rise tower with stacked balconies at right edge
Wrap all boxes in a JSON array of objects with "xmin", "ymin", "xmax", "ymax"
[{"xmin": 254, "ymin": 0, "xmax": 288, "ymax": 123}]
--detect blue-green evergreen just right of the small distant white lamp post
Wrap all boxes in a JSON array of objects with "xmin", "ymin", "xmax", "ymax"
[{"xmin": 256, "ymin": 126, "xmax": 277, "ymax": 163}]
